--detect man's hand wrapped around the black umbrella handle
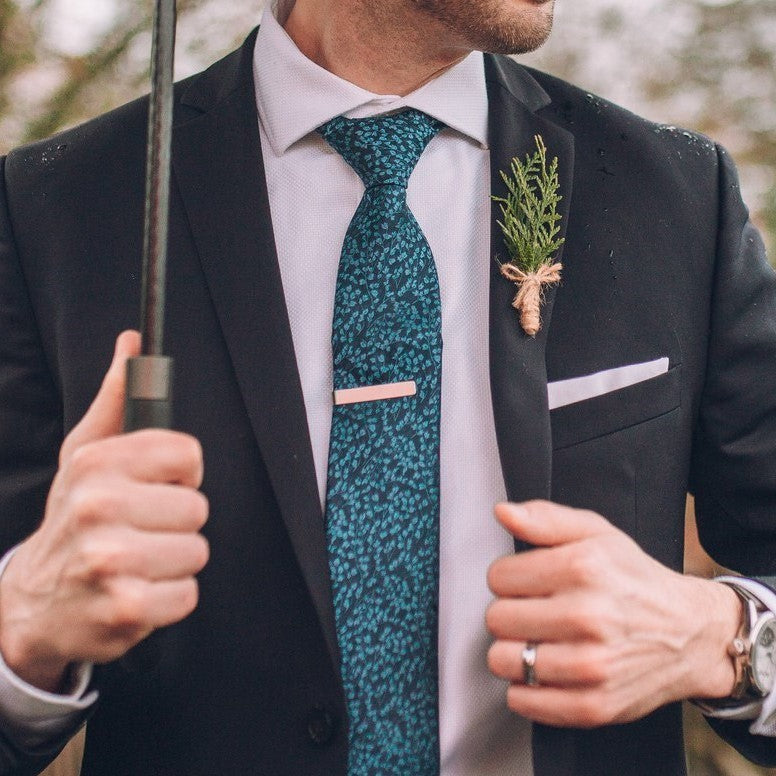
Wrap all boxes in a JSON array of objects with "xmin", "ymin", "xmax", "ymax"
[{"xmin": 0, "ymin": 332, "xmax": 208, "ymax": 692}]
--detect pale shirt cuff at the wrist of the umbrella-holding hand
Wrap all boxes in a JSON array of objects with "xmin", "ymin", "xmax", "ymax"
[{"xmin": 0, "ymin": 547, "xmax": 98, "ymax": 750}]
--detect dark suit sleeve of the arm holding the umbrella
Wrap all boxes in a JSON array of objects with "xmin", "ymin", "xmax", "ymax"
[{"xmin": 0, "ymin": 159, "xmax": 91, "ymax": 776}]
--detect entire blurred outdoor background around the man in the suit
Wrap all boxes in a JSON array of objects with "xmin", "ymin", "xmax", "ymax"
[{"xmin": 0, "ymin": 0, "xmax": 776, "ymax": 776}]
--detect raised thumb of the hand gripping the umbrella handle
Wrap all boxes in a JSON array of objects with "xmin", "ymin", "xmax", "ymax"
[{"xmin": 59, "ymin": 331, "xmax": 140, "ymax": 464}]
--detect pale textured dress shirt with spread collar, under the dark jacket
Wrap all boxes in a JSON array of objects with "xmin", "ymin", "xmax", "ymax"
[{"xmin": 0, "ymin": 0, "xmax": 776, "ymax": 776}]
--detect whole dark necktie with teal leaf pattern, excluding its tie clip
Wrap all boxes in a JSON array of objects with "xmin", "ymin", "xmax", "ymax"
[{"xmin": 319, "ymin": 110, "xmax": 442, "ymax": 776}]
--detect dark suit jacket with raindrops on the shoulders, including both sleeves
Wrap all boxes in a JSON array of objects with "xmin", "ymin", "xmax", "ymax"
[{"xmin": 0, "ymin": 28, "xmax": 776, "ymax": 776}]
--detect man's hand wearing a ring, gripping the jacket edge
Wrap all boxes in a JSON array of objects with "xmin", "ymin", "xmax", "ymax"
[{"xmin": 486, "ymin": 501, "xmax": 741, "ymax": 727}]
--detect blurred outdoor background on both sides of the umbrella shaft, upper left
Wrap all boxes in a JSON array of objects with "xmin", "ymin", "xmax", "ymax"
[{"xmin": 0, "ymin": 0, "xmax": 262, "ymax": 153}]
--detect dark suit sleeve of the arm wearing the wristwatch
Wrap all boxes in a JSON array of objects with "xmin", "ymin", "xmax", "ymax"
[{"xmin": 691, "ymin": 149, "xmax": 776, "ymax": 766}]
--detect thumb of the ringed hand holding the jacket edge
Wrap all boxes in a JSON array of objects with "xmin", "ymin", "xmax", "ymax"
[{"xmin": 495, "ymin": 501, "xmax": 615, "ymax": 547}]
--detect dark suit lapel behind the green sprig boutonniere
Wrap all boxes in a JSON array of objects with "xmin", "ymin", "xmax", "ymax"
[{"xmin": 486, "ymin": 56, "xmax": 574, "ymax": 516}]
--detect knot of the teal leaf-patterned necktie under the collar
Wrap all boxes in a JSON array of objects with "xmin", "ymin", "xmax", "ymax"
[{"xmin": 318, "ymin": 109, "xmax": 444, "ymax": 188}]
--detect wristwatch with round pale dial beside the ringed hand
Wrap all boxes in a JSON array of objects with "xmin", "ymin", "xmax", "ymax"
[{"xmin": 694, "ymin": 577, "xmax": 776, "ymax": 715}]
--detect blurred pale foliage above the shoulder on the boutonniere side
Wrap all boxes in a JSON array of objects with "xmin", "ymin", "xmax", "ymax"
[{"xmin": 525, "ymin": 0, "xmax": 776, "ymax": 261}]
